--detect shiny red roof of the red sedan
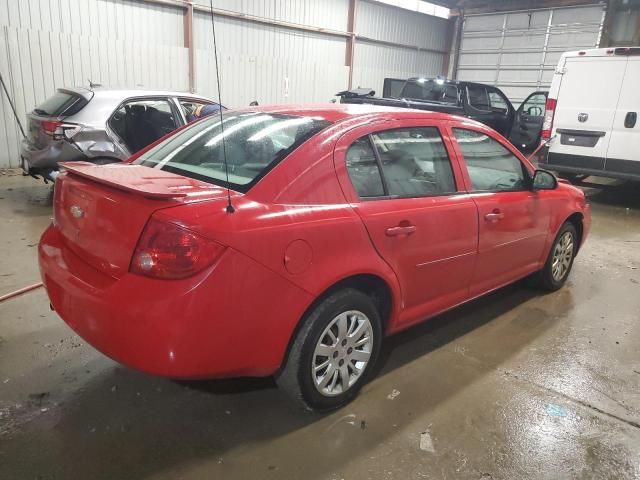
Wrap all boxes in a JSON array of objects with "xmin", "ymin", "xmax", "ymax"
[{"xmin": 230, "ymin": 103, "xmax": 469, "ymax": 123}]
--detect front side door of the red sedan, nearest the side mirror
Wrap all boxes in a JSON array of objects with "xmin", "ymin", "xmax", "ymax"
[{"xmin": 451, "ymin": 123, "xmax": 550, "ymax": 296}]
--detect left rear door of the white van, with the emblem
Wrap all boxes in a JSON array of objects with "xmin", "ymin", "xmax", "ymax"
[{"xmin": 552, "ymin": 56, "xmax": 627, "ymax": 170}]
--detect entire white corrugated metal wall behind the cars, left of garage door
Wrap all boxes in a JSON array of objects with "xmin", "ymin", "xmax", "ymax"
[{"xmin": 0, "ymin": 0, "xmax": 447, "ymax": 168}]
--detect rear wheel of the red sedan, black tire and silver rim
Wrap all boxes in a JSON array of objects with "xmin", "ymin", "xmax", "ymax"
[{"xmin": 276, "ymin": 288, "xmax": 382, "ymax": 411}]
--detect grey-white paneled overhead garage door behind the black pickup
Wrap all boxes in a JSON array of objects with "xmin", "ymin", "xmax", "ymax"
[{"xmin": 457, "ymin": 5, "xmax": 604, "ymax": 107}]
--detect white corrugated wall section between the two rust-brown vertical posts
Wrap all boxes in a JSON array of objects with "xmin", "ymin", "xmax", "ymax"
[{"xmin": 194, "ymin": 0, "xmax": 349, "ymax": 106}]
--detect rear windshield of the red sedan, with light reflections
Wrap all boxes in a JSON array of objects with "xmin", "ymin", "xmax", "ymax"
[{"xmin": 133, "ymin": 111, "xmax": 336, "ymax": 192}]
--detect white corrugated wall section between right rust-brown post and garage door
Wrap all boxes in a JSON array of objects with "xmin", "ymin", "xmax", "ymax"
[{"xmin": 353, "ymin": 1, "xmax": 448, "ymax": 94}]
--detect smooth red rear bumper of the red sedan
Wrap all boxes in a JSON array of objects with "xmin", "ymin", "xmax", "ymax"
[{"xmin": 38, "ymin": 226, "xmax": 312, "ymax": 378}]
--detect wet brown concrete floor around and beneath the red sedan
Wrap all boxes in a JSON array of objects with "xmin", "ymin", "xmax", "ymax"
[{"xmin": 0, "ymin": 176, "xmax": 640, "ymax": 480}]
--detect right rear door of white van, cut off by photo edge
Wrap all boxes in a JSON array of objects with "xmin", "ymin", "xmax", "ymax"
[{"xmin": 605, "ymin": 56, "xmax": 640, "ymax": 175}]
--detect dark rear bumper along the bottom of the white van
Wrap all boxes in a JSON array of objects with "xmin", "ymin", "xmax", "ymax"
[{"xmin": 540, "ymin": 152, "xmax": 640, "ymax": 181}]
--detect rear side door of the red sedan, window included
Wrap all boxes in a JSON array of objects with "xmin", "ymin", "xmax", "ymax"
[{"xmin": 334, "ymin": 120, "xmax": 478, "ymax": 324}]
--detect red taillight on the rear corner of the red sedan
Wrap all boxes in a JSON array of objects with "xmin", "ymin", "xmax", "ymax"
[{"xmin": 129, "ymin": 218, "xmax": 224, "ymax": 279}]
